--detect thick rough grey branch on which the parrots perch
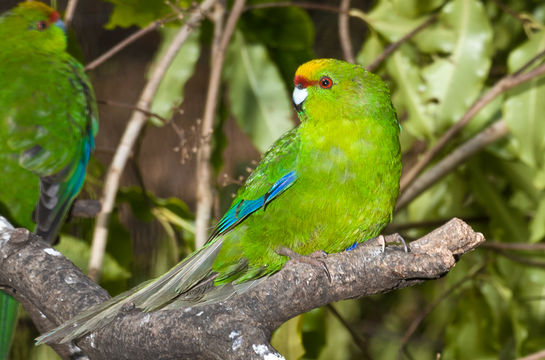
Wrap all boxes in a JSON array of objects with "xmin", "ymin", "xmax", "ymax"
[{"xmin": 0, "ymin": 219, "xmax": 484, "ymax": 360}]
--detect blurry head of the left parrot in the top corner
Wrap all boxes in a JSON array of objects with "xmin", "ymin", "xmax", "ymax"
[{"xmin": 1, "ymin": 1, "xmax": 66, "ymax": 52}]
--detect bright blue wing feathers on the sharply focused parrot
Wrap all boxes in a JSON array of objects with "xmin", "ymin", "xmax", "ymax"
[{"xmin": 210, "ymin": 170, "xmax": 297, "ymax": 239}]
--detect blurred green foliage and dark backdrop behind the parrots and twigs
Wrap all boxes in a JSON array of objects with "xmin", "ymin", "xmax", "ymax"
[{"xmin": 0, "ymin": 0, "xmax": 545, "ymax": 360}]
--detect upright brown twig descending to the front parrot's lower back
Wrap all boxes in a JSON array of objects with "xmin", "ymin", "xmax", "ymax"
[{"xmin": 195, "ymin": 0, "xmax": 245, "ymax": 248}]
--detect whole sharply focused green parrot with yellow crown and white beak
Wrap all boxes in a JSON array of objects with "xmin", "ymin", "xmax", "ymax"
[{"xmin": 37, "ymin": 59, "xmax": 401, "ymax": 343}]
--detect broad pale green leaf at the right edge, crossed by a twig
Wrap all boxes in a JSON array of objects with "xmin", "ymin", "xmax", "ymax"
[{"xmin": 503, "ymin": 30, "xmax": 545, "ymax": 168}]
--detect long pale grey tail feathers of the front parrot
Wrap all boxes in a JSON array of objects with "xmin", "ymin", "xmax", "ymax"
[{"xmin": 36, "ymin": 238, "xmax": 223, "ymax": 344}]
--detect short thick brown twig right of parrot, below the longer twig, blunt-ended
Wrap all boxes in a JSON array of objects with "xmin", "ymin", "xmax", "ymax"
[{"xmin": 396, "ymin": 119, "xmax": 509, "ymax": 211}]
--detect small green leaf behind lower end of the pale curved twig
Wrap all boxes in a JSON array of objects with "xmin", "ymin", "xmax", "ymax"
[{"xmin": 55, "ymin": 235, "xmax": 131, "ymax": 281}]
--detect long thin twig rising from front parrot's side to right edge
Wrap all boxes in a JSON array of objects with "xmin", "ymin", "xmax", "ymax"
[{"xmin": 401, "ymin": 60, "xmax": 545, "ymax": 192}]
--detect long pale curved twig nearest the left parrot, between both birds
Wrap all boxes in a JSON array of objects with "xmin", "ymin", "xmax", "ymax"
[{"xmin": 89, "ymin": 0, "xmax": 217, "ymax": 281}]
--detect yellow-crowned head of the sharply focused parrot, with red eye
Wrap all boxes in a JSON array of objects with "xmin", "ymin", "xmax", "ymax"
[{"xmin": 292, "ymin": 59, "xmax": 393, "ymax": 126}]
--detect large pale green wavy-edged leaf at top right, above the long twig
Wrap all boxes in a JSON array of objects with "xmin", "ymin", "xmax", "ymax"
[{"xmin": 416, "ymin": 0, "xmax": 492, "ymax": 131}]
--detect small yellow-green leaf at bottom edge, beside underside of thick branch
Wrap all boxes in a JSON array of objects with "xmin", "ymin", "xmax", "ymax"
[{"xmin": 271, "ymin": 315, "xmax": 305, "ymax": 360}]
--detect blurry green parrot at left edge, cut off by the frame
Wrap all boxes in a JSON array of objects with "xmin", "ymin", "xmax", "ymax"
[{"xmin": 0, "ymin": 1, "xmax": 98, "ymax": 359}]
